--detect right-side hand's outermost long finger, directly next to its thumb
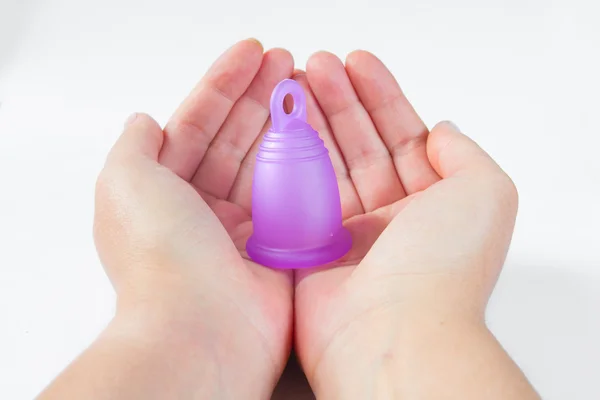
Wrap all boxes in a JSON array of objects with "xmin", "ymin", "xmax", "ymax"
[{"xmin": 346, "ymin": 51, "xmax": 440, "ymax": 194}]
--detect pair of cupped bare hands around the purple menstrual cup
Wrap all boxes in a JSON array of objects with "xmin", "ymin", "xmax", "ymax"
[{"xmin": 40, "ymin": 40, "xmax": 536, "ymax": 399}]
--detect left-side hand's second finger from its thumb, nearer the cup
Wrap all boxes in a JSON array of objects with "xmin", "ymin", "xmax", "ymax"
[{"xmin": 191, "ymin": 49, "xmax": 294, "ymax": 199}]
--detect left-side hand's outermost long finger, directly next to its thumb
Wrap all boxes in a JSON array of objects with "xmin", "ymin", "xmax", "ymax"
[{"xmin": 159, "ymin": 39, "xmax": 263, "ymax": 180}]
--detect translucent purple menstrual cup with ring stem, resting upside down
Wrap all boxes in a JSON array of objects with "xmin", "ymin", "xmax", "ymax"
[{"xmin": 246, "ymin": 79, "xmax": 352, "ymax": 269}]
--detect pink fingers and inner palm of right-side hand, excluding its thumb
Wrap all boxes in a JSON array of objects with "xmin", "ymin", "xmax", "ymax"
[{"xmin": 288, "ymin": 52, "xmax": 439, "ymax": 268}]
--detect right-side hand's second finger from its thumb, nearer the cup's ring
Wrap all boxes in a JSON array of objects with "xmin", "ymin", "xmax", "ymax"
[{"xmin": 307, "ymin": 52, "xmax": 406, "ymax": 212}]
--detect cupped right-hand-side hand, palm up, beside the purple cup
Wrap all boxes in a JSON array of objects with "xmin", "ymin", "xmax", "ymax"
[{"xmin": 295, "ymin": 51, "xmax": 528, "ymax": 399}]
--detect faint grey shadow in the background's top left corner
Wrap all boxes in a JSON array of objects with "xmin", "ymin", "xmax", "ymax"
[{"xmin": 0, "ymin": 0, "xmax": 37, "ymax": 73}]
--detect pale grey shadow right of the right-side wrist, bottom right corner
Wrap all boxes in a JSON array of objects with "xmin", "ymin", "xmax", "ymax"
[{"xmin": 488, "ymin": 261, "xmax": 600, "ymax": 399}]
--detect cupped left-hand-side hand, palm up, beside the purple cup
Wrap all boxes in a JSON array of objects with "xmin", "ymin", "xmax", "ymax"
[{"xmin": 94, "ymin": 40, "xmax": 293, "ymax": 398}]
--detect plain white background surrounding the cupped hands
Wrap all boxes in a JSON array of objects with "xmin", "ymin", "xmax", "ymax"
[{"xmin": 0, "ymin": 0, "xmax": 600, "ymax": 399}]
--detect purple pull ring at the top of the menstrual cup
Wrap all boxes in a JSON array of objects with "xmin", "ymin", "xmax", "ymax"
[{"xmin": 271, "ymin": 79, "xmax": 306, "ymax": 132}]
